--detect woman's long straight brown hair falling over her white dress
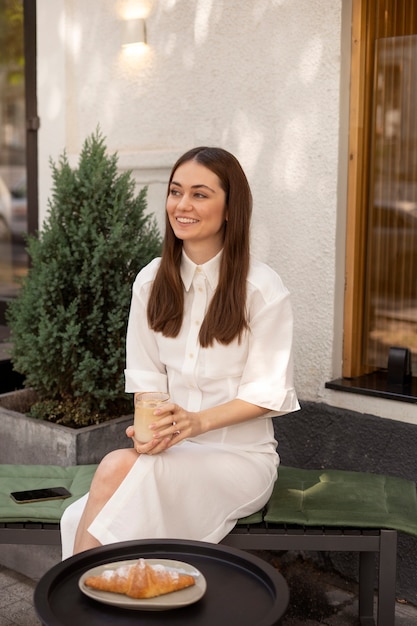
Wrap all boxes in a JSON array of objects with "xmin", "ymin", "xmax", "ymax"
[{"xmin": 147, "ymin": 147, "xmax": 252, "ymax": 347}]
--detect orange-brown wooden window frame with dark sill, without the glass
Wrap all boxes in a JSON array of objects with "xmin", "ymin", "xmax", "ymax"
[{"xmin": 332, "ymin": 0, "xmax": 417, "ymax": 404}]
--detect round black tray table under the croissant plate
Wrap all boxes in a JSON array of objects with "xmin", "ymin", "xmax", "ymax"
[{"xmin": 34, "ymin": 539, "xmax": 289, "ymax": 626}]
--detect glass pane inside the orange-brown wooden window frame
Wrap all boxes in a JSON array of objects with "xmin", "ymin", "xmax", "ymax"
[{"xmin": 365, "ymin": 34, "xmax": 417, "ymax": 371}]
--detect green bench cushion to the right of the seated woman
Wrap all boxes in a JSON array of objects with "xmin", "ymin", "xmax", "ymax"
[{"xmin": 264, "ymin": 466, "xmax": 417, "ymax": 536}]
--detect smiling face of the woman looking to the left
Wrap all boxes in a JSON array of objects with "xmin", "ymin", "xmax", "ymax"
[{"xmin": 166, "ymin": 161, "xmax": 227, "ymax": 264}]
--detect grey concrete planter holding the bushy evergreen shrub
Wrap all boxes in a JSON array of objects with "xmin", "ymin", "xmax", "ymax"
[{"xmin": 0, "ymin": 389, "xmax": 133, "ymax": 466}]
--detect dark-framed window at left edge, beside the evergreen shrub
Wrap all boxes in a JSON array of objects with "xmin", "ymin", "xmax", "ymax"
[{"xmin": 0, "ymin": 0, "xmax": 38, "ymax": 325}]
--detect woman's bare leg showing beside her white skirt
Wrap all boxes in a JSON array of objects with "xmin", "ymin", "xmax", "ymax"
[{"xmin": 74, "ymin": 448, "xmax": 138, "ymax": 554}]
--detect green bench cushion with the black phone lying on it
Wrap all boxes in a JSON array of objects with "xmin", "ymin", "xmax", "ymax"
[{"xmin": 0, "ymin": 465, "xmax": 97, "ymax": 523}]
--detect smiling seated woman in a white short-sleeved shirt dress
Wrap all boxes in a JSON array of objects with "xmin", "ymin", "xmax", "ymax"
[{"xmin": 61, "ymin": 147, "xmax": 299, "ymax": 558}]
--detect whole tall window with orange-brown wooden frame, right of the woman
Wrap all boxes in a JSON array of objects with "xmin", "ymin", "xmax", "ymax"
[{"xmin": 327, "ymin": 0, "xmax": 417, "ymax": 402}]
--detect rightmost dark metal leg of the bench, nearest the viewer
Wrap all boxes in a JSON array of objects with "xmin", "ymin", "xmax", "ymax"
[{"xmin": 377, "ymin": 530, "xmax": 397, "ymax": 626}]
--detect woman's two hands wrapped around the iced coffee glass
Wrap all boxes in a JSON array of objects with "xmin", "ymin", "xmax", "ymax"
[{"xmin": 126, "ymin": 403, "xmax": 202, "ymax": 454}]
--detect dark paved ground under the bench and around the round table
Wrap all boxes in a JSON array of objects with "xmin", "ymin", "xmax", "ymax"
[{"xmin": 0, "ymin": 562, "xmax": 417, "ymax": 626}]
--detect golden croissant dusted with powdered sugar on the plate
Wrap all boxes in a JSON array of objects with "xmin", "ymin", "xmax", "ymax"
[{"xmin": 84, "ymin": 559, "xmax": 195, "ymax": 599}]
